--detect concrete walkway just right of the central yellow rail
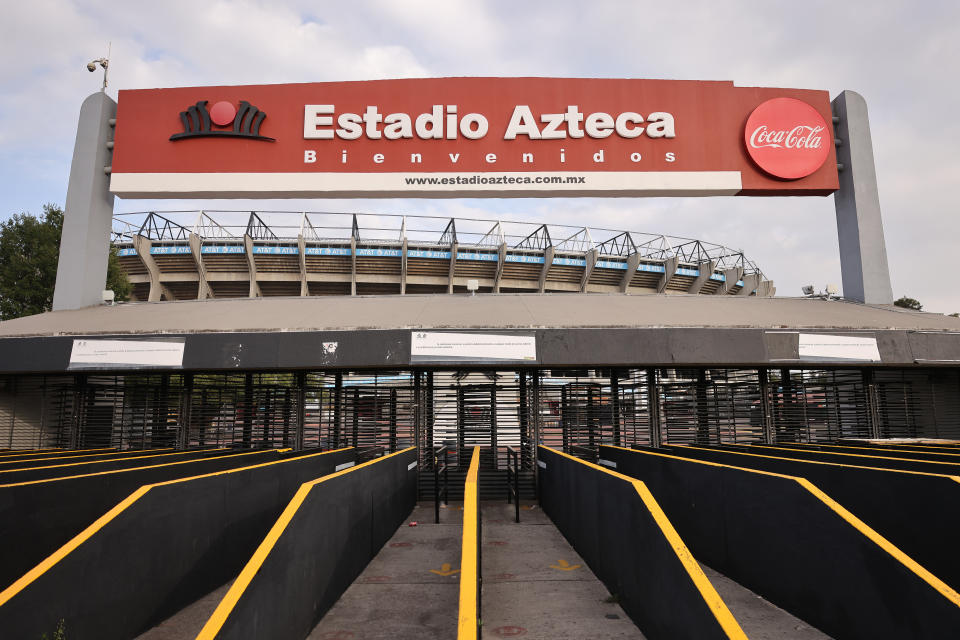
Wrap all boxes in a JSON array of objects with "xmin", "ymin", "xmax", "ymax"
[{"xmin": 481, "ymin": 502, "xmax": 644, "ymax": 640}]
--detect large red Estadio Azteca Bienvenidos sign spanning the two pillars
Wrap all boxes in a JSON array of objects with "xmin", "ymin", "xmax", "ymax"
[{"xmin": 111, "ymin": 78, "xmax": 838, "ymax": 197}]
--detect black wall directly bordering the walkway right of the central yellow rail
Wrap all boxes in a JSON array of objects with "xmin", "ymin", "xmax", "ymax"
[{"xmin": 539, "ymin": 447, "xmax": 744, "ymax": 639}]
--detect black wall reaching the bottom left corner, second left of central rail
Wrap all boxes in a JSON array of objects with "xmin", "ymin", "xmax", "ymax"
[{"xmin": 0, "ymin": 449, "xmax": 355, "ymax": 640}]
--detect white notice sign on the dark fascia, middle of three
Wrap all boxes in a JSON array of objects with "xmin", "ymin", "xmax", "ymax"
[{"xmin": 410, "ymin": 331, "xmax": 537, "ymax": 361}]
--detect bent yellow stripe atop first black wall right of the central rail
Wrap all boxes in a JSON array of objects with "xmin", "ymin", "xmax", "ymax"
[{"xmin": 540, "ymin": 445, "xmax": 747, "ymax": 640}]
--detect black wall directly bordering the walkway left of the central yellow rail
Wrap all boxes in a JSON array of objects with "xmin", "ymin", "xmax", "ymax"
[{"xmin": 216, "ymin": 449, "xmax": 417, "ymax": 638}]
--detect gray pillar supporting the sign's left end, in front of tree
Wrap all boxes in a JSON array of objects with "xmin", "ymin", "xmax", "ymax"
[{"xmin": 53, "ymin": 93, "xmax": 117, "ymax": 311}]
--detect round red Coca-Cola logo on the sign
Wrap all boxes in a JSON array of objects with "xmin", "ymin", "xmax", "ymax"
[{"xmin": 743, "ymin": 98, "xmax": 832, "ymax": 180}]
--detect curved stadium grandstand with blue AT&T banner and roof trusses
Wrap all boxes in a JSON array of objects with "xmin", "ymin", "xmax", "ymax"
[{"xmin": 113, "ymin": 211, "xmax": 775, "ymax": 301}]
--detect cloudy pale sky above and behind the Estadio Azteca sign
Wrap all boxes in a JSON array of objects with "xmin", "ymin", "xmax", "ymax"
[{"xmin": 0, "ymin": 0, "xmax": 960, "ymax": 313}]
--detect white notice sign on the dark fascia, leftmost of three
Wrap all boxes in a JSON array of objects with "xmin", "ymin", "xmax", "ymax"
[{"xmin": 68, "ymin": 338, "xmax": 184, "ymax": 369}]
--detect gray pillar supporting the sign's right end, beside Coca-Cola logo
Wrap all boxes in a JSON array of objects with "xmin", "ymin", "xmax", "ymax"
[{"xmin": 833, "ymin": 91, "xmax": 893, "ymax": 304}]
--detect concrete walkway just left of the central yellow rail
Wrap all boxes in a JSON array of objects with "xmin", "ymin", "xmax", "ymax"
[{"xmin": 308, "ymin": 502, "xmax": 463, "ymax": 640}]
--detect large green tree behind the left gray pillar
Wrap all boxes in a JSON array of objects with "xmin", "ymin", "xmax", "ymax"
[{"xmin": 0, "ymin": 204, "xmax": 131, "ymax": 320}]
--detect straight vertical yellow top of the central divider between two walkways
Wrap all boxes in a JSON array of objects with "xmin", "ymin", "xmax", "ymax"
[{"xmin": 457, "ymin": 447, "xmax": 480, "ymax": 640}]
